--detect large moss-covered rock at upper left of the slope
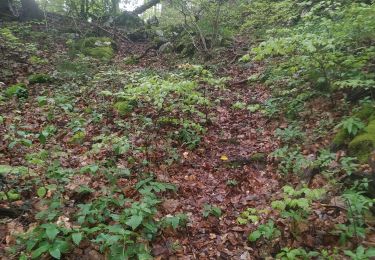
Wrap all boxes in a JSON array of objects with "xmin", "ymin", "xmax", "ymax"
[{"xmin": 71, "ymin": 37, "xmax": 114, "ymax": 61}]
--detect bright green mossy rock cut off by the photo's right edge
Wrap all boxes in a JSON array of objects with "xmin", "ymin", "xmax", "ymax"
[{"xmin": 348, "ymin": 120, "xmax": 375, "ymax": 163}]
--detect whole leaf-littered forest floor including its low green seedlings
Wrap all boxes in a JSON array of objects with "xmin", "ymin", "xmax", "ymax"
[{"xmin": 0, "ymin": 22, "xmax": 374, "ymax": 260}]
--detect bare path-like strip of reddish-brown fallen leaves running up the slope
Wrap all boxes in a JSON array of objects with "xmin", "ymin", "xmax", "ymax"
[{"xmin": 150, "ymin": 62, "xmax": 280, "ymax": 259}]
